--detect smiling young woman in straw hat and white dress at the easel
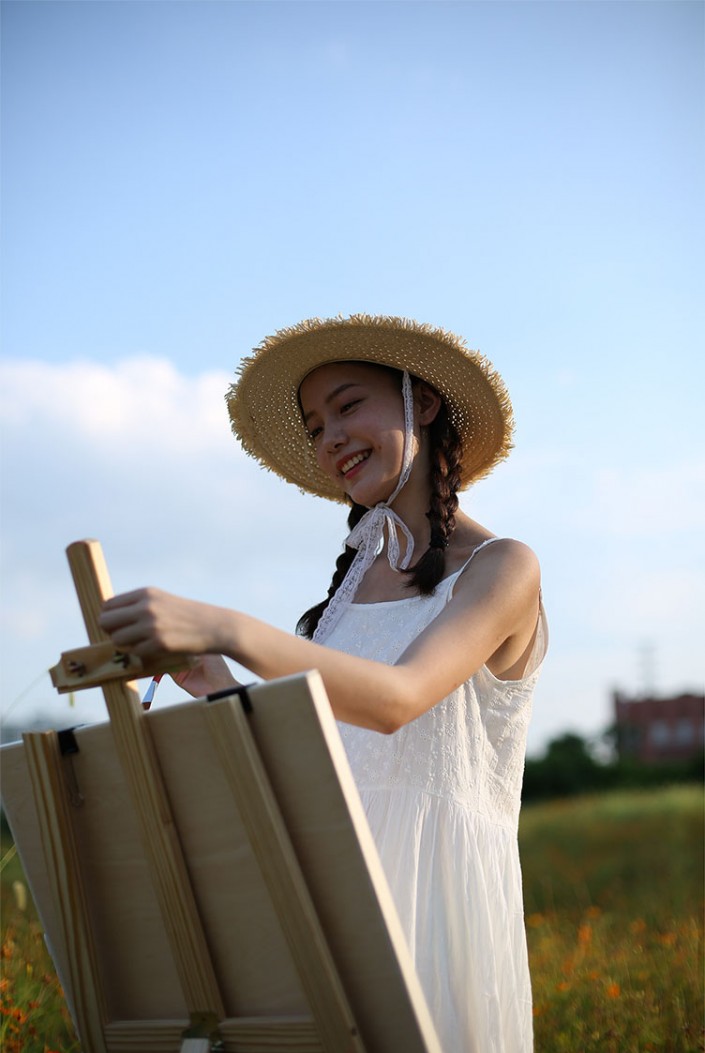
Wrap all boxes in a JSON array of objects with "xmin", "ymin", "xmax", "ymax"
[{"xmin": 102, "ymin": 316, "xmax": 547, "ymax": 1053}]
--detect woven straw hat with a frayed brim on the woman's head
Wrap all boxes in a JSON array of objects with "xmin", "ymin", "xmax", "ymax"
[{"xmin": 226, "ymin": 315, "xmax": 513, "ymax": 502}]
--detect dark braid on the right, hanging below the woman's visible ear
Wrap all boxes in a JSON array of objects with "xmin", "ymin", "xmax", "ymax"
[{"xmin": 404, "ymin": 402, "xmax": 462, "ymax": 596}]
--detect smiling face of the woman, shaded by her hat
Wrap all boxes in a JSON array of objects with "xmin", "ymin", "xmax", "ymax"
[{"xmin": 299, "ymin": 362, "xmax": 404, "ymax": 508}]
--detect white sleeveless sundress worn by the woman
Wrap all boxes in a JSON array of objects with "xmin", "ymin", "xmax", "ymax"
[{"xmin": 325, "ymin": 538, "xmax": 547, "ymax": 1053}]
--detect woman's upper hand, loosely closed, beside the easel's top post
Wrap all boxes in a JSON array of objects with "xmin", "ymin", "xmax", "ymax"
[{"xmin": 99, "ymin": 589, "xmax": 221, "ymax": 658}]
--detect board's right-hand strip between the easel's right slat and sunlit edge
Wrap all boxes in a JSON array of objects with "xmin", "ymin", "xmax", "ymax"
[{"xmin": 231, "ymin": 672, "xmax": 440, "ymax": 1053}]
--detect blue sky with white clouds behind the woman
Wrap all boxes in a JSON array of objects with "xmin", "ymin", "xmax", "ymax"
[{"xmin": 0, "ymin": 0, "xmax": 705, "ymax": 750}]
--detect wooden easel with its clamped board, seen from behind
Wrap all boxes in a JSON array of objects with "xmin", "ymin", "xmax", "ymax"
[{"xmin": 2, "ymin": 541, "xmax": 440, "ymax": 1053}]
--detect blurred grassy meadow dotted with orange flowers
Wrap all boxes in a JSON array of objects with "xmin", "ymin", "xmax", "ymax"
[{"xmin": 0, "ymin": 787, "xmax": 705, "ymax": 1053}]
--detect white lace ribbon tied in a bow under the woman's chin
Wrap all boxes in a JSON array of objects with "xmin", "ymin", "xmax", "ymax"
[{"xmin": 314, "ymin": 370, "xmax": 414, "ymax": 643}]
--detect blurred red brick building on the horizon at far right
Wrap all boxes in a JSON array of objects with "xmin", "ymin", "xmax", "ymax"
[{"xmin": 612, "ymin": 691, "xmax": 705, "ymax": 764}]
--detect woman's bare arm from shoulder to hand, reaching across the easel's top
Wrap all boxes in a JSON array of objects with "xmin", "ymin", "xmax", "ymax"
[{"xmin": 101, "ymin": 541, "xmax": 539, "ymax": 733}]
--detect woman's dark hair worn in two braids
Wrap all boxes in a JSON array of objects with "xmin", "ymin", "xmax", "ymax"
[{"xmin": 297, "ymin": 379, "xmax": 462, "ymax": 639}]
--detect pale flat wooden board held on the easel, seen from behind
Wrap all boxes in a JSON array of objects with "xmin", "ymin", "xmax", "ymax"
[{"xmin": 0, "ymin": 673, "xmax": 440, "ymax": 1053}]
